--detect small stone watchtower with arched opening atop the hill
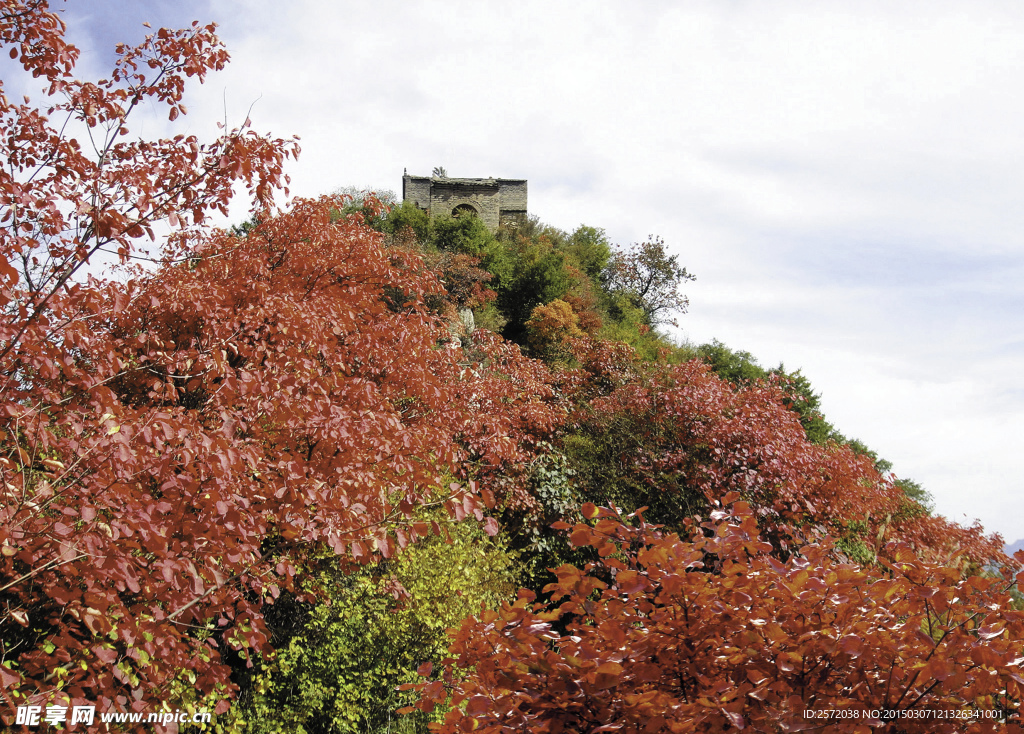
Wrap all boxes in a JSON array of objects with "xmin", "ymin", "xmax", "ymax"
[{"xmin": 401, "ymin": 172, "xmax": 526, "ymax": 232}]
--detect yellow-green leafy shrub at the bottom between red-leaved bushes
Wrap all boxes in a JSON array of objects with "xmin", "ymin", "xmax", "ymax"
[{"xmin": 237, "ymin": 518, "xmax": 516, "ymax": 734}]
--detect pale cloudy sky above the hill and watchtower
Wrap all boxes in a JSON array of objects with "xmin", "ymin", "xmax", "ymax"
[{"xmin": 54, "ymin": 0, "xmax": 1024, "ymax": 542}]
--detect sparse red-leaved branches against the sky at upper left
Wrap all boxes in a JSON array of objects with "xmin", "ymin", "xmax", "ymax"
[{"xmin": 0, "ymin": 0, "xmax": 298, "ymax": 356}]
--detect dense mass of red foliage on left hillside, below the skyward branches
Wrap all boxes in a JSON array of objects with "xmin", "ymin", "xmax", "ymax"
[{"xmin": 0, "ymin": 194, "xmax": 511, "ymax": 705}]
